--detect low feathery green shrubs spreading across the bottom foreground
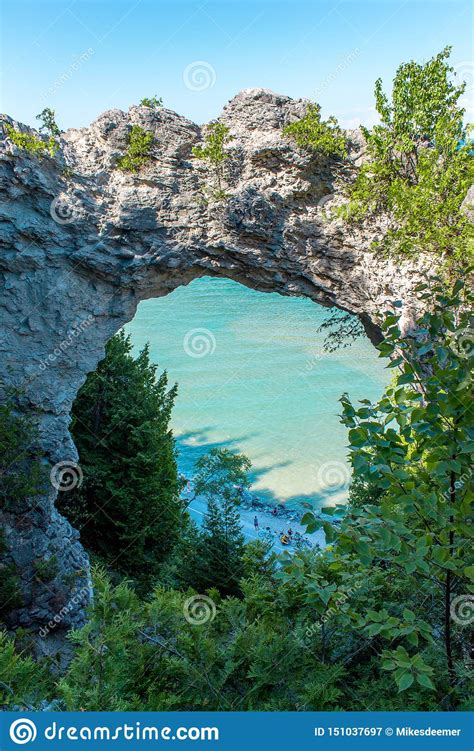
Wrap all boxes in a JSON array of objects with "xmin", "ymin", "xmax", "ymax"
[{"xmin": 51, "ymin": 553, "xmax": 466, "ymax": 711}]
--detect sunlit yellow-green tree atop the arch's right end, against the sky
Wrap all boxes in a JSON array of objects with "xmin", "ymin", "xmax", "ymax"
[{"xmin": 341, "ymin": 47, "xmax": 473, "ymax": 264}]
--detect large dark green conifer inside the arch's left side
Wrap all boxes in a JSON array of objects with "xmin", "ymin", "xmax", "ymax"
[{"xmin": 59, "ymin": 332, "xmax": 182, "ymax": 581}]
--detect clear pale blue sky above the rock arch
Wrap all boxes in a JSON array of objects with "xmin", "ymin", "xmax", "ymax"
[{"xmin": 1, "ymin": 0, "xmax": 474, "ymax": 128}]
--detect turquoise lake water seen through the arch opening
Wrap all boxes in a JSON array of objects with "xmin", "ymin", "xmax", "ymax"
[{"xmin": 126, "ymin": 278, "xmax": 389, "ymax": 516}]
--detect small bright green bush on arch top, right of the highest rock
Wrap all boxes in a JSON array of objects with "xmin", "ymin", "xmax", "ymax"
[{"xmin": 283, "ymin": 103, "xmax": 347, "ymax": 157}]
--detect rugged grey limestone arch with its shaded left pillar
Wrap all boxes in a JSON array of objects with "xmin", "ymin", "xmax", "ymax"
[{"xmin": 0, "ymin": 89, "xmax": 419, "ymax": 629}]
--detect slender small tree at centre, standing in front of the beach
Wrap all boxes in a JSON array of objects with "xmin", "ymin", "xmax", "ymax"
[{"xmin": 195, "ymin": 449, "xmax": 250, "ymax": 594}]
